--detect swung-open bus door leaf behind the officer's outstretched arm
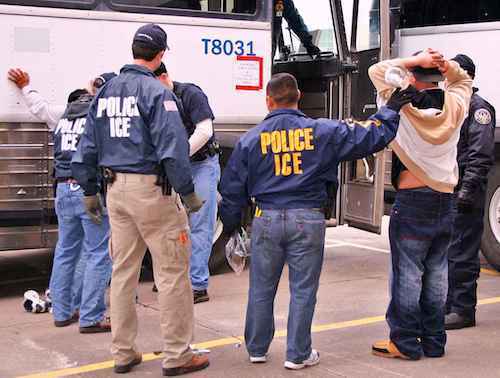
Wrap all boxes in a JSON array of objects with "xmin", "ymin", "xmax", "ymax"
[{"xmin": 340, "ymin": 0, "xmax": 389, "ymax": 233}]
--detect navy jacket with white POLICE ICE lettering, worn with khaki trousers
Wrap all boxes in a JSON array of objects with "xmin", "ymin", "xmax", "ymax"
[{"xmin": 71, "ymin": 65, "xmax": 194, "ymax": 195}]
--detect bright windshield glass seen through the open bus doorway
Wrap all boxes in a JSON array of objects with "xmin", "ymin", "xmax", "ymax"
[{"xmin": 282, "ymin": 0, "xmax": 337, "ymax": 54}]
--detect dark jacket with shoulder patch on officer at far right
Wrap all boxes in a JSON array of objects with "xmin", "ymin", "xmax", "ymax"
[{"xmin": 455, "ymin": 88, "xmax": 496, "ymax": 207}]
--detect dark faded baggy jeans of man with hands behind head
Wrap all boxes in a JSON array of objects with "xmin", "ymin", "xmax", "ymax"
[{"xmin": 386, "ymin": 188, "xmax": 452, "ymax": 359}]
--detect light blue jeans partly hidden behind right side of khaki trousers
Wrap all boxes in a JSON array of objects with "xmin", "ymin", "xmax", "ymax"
[{"xmin": 189, "ymin": 155, "xmax": 220, "ymax": 290}]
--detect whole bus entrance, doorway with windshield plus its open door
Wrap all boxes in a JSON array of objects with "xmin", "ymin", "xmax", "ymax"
[{"xmin": 273, "ymin": 0, "xmax": 387, "ymax": 233}]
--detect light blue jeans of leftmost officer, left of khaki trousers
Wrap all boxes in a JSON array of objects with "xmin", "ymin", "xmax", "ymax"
[{"xmin": 50, "ymin": 183, "xmax": 111, "ymax": 327}]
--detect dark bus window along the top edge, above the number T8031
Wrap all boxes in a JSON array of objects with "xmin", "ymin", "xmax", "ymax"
[{"xmin": 112, "ymin": 0, "xmax": 256, "ymax": 14}]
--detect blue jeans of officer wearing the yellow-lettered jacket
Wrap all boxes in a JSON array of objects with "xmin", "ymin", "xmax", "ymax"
[{"xmin": 245, "ymin": 209, "xmax": 325, "ymax": 363}]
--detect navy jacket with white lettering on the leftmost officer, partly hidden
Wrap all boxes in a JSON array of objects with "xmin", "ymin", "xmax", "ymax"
[{"xmin": 54, "ymin": 95, "xmax": 93, "ymax": 179}]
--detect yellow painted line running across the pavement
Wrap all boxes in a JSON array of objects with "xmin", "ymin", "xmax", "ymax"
[{"xmin": 18, "ymin": 297, "xmax": 500, "ymax": 378}]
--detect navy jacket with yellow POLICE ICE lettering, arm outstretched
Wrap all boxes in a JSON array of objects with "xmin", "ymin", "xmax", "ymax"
[{"xmin": 220, "ymin": 107, "xmax": 399, "ymax": 227}]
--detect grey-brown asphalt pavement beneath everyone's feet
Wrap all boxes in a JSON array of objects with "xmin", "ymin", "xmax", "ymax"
[{"xmin": 0, "ymin": 219, "xmax": 500, "ymax": 378}]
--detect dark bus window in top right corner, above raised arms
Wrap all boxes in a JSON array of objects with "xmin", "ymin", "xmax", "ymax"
[{"xmin": 401, "ymin": 0, "xmax": 500, "ymax": 28}]
